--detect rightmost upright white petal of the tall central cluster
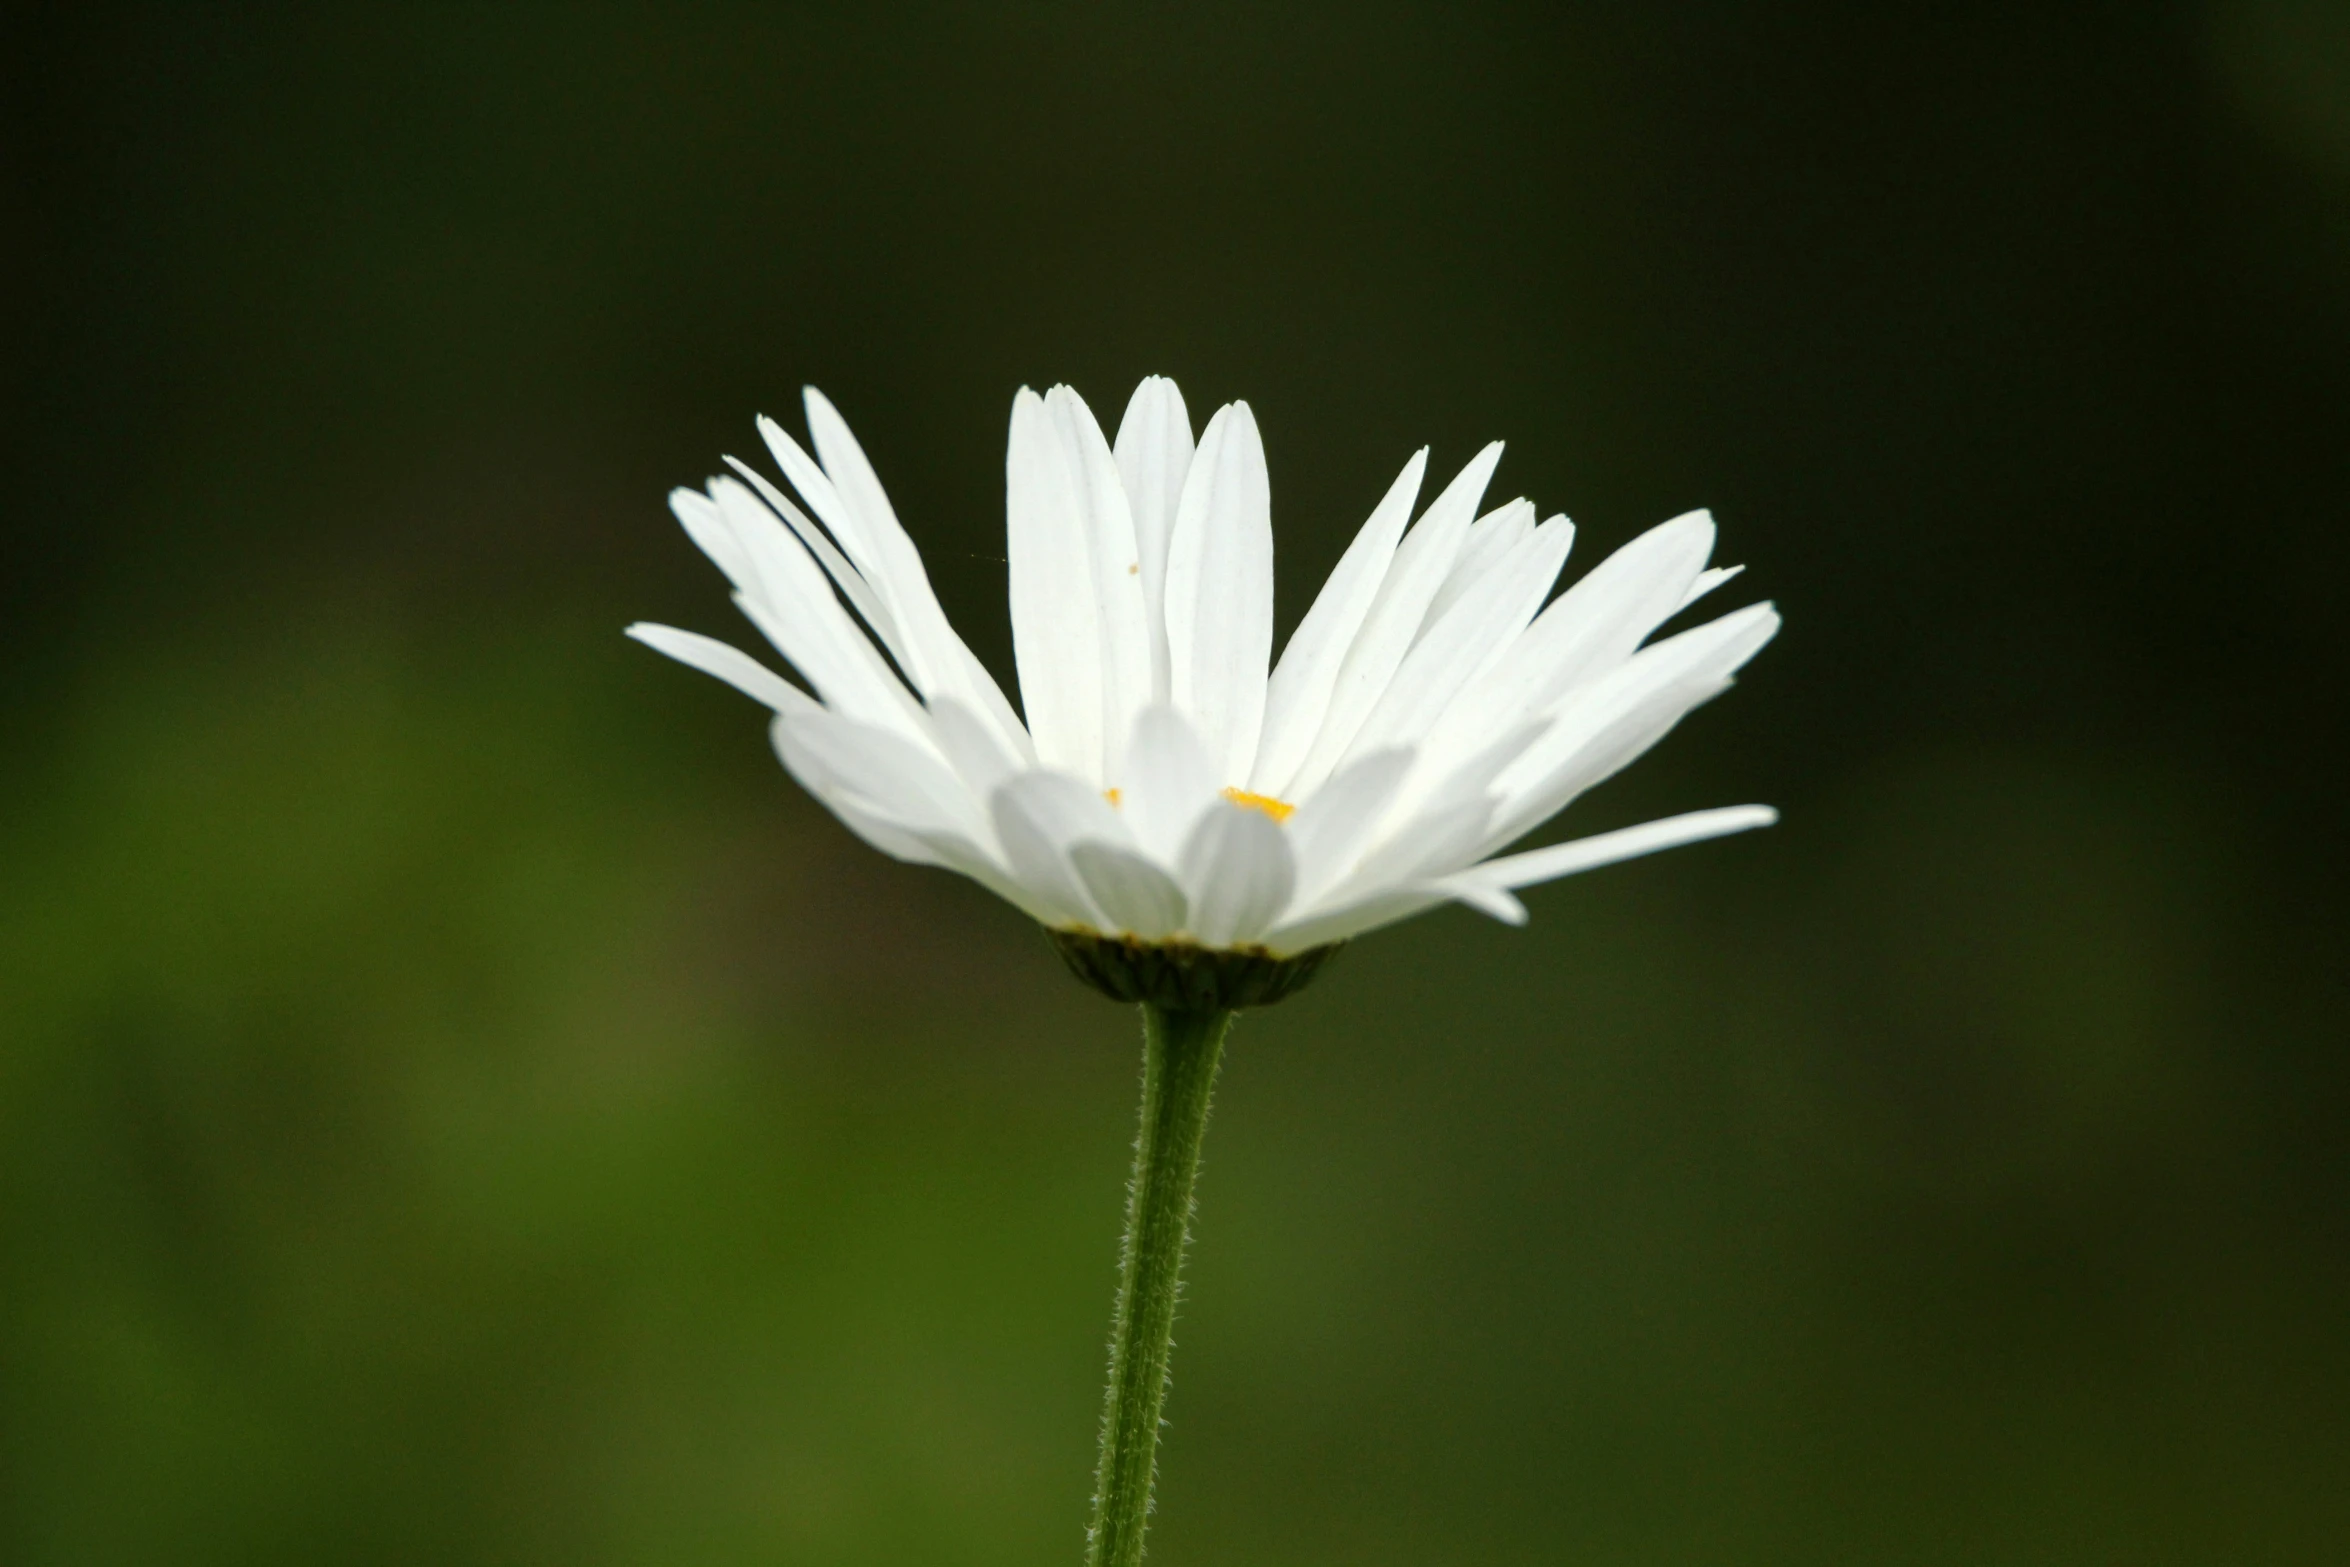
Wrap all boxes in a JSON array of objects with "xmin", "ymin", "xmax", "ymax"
[{"xmin": 1166, "ymin": 402, "xmax": 1274, "ymax": 785}]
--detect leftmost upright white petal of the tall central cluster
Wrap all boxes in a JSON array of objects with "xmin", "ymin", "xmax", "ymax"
[{"xmin": 1003, "ymin": 388, "xmax": 1107, "ymax": 785}]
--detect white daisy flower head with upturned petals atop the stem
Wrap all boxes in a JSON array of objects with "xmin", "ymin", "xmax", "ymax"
[{"xmin": 630, "ymin": 376, "xmax": 1779, "ymax": 1003}]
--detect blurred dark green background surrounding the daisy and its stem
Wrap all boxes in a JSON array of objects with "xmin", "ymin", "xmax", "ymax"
[{"xmin": 0, "ymin": 0, "xmax": 2350, "ymax": 1567}]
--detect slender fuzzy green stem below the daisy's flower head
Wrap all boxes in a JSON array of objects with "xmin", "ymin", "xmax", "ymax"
[{"xmin": 1086, "ymin": 1003, "xmax": 1234, "ymax": 1567}]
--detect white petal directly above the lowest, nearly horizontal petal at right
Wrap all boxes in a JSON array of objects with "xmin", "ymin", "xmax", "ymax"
[{"xmin": 1488, "ymin": 604, "xmax": 1779, "ymax": 848}]
